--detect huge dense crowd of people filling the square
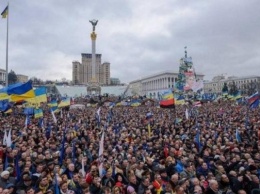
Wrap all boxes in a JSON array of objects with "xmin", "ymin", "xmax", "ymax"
[{"xmin": 0, "ymin": 98, "xmax": 260, "ymax": 194}]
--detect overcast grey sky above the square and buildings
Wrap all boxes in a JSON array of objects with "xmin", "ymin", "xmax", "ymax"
[{"xmin": 0, "ymin": 0, "xmax": 260, "ymax": 82}]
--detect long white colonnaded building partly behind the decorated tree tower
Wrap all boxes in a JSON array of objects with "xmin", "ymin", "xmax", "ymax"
[{"xmin": 129, "ymin": 71, "xmax": 204, "ymax": 98}]
